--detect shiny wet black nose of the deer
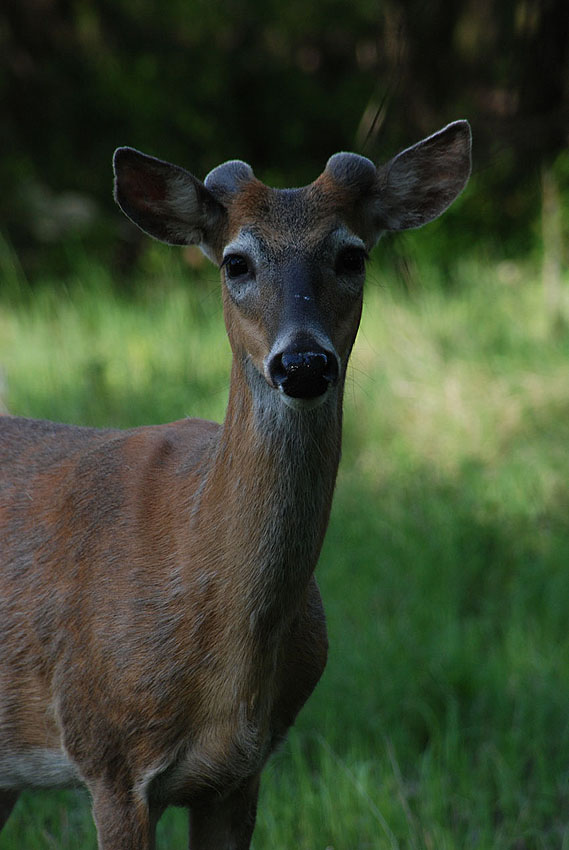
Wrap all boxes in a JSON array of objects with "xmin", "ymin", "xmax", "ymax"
[{"xmin": 268, "ymin": 350, "xmax": 338, "ymax": 398}]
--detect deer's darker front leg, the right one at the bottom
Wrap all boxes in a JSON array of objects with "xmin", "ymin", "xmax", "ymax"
[{"xmin": 190, "ymin": 776, "xmax": 259, "ymax": 850}]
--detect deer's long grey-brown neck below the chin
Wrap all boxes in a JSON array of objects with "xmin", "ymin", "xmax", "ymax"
[{"xmin": 197, "ymin": 352, "xmax": 342, "ymax": 619}]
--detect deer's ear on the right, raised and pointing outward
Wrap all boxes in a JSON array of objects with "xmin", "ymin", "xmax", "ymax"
[{"xmin": 370, "ymin": 121, "xmax": 472, "ymax": 236}]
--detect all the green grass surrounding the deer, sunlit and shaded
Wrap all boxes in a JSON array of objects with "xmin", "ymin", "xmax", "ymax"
[{"xmin": 0, "ymin": 248, "xmax": 569, "ymax": 850}]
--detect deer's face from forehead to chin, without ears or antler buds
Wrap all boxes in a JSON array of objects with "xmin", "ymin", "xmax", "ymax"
[{"xmin": 215, "ymin": 182, "xmax": 367, "ymax": 408}]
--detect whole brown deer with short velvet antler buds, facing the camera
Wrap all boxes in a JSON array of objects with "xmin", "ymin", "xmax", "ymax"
[{"xmin": 0, "ymin": 121, "xmax": 470, "ymax": 850}]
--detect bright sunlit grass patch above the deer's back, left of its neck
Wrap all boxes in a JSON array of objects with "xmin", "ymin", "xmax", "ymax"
[{"xmin": 0, "ymin": 253, "xmax": 230, "ymax": 427}]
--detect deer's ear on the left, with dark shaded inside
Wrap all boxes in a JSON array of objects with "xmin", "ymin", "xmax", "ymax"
[{"xmin": 113, "ymin": 148, "xmax": 227, "ymax": 256}]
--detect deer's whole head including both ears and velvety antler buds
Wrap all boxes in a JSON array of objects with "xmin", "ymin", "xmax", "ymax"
[{"xmin": 114, "ymin": 121, "xmax": 470, "ymax": 409}]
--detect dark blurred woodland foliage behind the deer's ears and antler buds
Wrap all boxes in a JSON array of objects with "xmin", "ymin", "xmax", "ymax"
[{"xmin": 0, "ymin": 0, "xmax": 569, "ymax": 280}]
